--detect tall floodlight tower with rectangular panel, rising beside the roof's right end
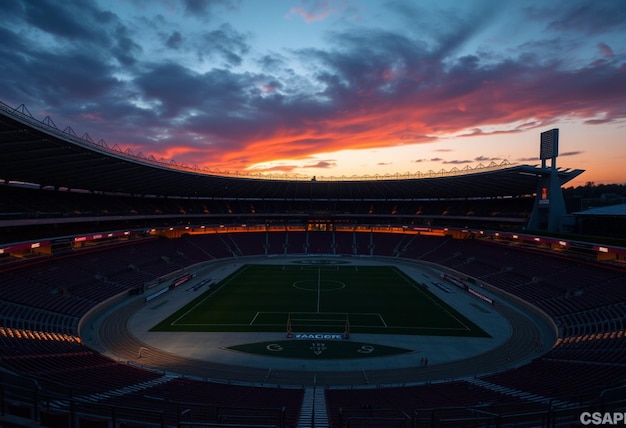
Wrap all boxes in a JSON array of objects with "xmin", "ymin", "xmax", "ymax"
[{"xmin": 528, "ymin": 128, "xmax": 567, "ymax": 232}]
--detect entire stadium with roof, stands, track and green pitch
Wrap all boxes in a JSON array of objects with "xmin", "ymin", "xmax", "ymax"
[{"xmin": 0, "ymin": 104, "xmax": 626, "ymax": 427}]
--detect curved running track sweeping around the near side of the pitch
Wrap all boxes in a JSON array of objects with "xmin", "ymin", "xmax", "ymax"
[{"xmin": 98, "ymin": 274, "xmax": 552, "ymax": 386}]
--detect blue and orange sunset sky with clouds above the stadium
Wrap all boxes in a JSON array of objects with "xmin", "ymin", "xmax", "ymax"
[{"xmin": 0, "ymin": 0, "xmax": 626, "ymax": 186}]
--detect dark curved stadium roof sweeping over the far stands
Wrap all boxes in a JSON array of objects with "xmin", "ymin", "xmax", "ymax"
[{"xmin": 0, "ymin": 103, "xmax": 583, "ymax": 200}]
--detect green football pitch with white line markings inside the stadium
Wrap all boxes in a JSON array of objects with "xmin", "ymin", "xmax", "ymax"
[{"xmin": 152, "ymin": 264, "xmax": 489, "ymax": 337}]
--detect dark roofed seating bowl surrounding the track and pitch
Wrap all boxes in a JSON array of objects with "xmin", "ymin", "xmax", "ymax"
[{"xmin": 0, "ymin": 104, "xmax": 626, "ymax": 427}]
